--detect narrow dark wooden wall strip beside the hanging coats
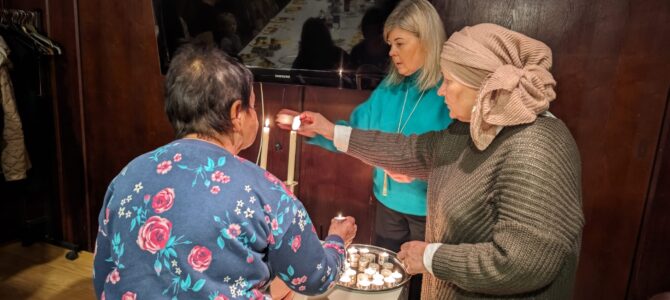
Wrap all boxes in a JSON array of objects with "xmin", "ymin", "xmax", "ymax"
[{"xmin": 46, "ymin": 0, "xmax": 88, "ymax": 247}]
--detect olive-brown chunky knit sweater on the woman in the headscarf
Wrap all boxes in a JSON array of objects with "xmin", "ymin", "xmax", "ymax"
[{"xmin": 348, "ymin": 117, "xmax": 584, "ymax": 300}]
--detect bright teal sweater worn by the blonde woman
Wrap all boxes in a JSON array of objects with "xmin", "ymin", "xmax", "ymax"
[{"xmin": 307, "ymin": 72, "xmax": 451, "ymax": 216}]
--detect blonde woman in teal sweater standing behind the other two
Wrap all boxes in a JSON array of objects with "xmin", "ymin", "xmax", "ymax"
[{"xmin": 276, "ymin": 0, "xmax": 451, "ymax": 299}]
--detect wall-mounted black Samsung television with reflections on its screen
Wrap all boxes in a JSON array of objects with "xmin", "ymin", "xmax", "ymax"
[{"xmin": 153, "ymin": 0, "xmax": 398, "ymax": 89}]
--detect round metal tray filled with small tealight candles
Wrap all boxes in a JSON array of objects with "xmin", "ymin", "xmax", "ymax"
[{"xmin": 337, "ymin": 244, "xmax": 411, "ymax": 293}]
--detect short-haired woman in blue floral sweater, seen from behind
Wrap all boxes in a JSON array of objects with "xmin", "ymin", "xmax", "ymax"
[{"xmin": 94, "ymin": 45, "xmax": 356, "ymax": 300}]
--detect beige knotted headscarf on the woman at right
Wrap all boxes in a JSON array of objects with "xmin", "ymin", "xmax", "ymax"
[{"xmin": 441, "ymin": 24, "xmax": 556, "ymax": 150}]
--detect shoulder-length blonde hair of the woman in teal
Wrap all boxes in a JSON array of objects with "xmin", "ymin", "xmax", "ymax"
[{"xmin": 384, "ymin": 0, "xmax": 446, "ymax": 91}]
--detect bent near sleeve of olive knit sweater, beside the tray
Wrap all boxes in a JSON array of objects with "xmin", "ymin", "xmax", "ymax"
[{"xmin": 432, "ymin": 123, "xmax": 584, "ymax": 295}]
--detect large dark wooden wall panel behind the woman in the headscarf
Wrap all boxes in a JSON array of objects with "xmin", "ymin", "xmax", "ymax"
[{"xmin": 432, "ymin": 0, "xmax": 670, "ymax": 299}]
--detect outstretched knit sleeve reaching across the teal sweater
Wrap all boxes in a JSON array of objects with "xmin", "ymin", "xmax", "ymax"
[{"xmin": 347, "ymin": 129, "xmax": 439, "ymax": 180}]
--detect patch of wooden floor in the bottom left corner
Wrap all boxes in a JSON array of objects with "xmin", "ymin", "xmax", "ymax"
[{"xmin": 0, "ymin": 243, "xmax": 95, "ymax": 300}]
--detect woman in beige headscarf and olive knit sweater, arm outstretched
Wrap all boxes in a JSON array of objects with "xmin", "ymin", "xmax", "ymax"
[{"xmin": 292, "ymin": 24, "xmax": 584, "ymax": 299}]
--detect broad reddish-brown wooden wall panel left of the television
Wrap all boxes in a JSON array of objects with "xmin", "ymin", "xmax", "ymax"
[{"xmin": 78, "ymin": 0, "xmax": 174, "ymax": 249}]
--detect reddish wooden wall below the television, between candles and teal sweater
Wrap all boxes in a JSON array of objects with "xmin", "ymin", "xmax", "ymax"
[{"xmin": 298, "ymin": 87, "xmax": 374, "ymax": 244}]
